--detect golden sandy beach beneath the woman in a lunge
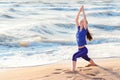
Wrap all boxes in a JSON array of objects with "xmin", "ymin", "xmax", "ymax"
[{"xmin": 0, "ymin": 58, "xmax": 120, "ymax": 80}]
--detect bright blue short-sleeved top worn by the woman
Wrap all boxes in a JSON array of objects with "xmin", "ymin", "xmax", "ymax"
[{"xmin": 76, "ymin": 26, "xmax": 87, "ymax": 46}]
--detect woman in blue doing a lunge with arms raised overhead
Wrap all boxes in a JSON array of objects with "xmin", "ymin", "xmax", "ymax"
[{"xmin": 72, "ymin": 6, "xmax": 96, "ymax": 71}]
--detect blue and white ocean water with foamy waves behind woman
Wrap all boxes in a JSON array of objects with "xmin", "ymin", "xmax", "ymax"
[{"xmin": 0, "ymin": 0, "xmax": 120, "ymax": 68}]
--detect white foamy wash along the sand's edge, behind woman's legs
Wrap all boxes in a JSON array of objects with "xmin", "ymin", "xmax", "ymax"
[{"xmin": 0, "ymin": 43, "xmax": 120, "ymax": 69}]
